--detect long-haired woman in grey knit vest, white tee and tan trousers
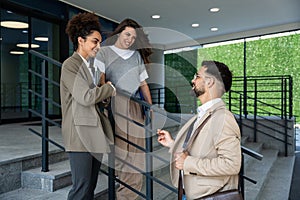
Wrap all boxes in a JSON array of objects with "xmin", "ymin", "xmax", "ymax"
[{"xmin": 95, "ymin": 19, "xmax": 152, "ymax": 200}]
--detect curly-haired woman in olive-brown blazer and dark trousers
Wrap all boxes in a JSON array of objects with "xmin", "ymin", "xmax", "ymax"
[{"xmin": 60, "ymin": 13, "xmax": 115, "ymax": 200}]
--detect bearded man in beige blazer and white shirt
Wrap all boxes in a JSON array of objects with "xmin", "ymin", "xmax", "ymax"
[{"xmin": 157, "ymin": 61, "xmax": 241, "ymax": 199}]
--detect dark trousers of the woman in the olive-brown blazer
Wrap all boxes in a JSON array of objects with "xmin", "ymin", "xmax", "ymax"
[{"xmin": 68, "ymin": 152, "xmax": 103, "ymax": 200}]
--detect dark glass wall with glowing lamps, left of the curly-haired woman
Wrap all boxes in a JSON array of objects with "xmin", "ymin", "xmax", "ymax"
[{"xmin": 0, "ymin": 0, "xmax": 117, "ymax": 124}]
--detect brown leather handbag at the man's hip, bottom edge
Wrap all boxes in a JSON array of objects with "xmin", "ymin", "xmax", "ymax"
[{"xmin": 198, "ymin": 189, "xmax": 243, "ymax": 200}]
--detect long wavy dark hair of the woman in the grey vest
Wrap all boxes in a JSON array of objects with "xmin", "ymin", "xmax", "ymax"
[{"xmin": 106, "ymin": 18, "xmax": 152, "ymax": 64}]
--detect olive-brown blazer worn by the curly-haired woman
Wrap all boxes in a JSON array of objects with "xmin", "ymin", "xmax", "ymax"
[{"xmin": 60, "ymin": 52, "xmax": 114, "ymax": 153}]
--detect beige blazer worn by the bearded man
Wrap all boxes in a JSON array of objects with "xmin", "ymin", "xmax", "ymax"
[{"xmin": 170, "ymin": 101, "xmax": 241, "ymax": 199}]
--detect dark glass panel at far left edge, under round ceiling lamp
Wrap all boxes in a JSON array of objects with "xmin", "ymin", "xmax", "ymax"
[{"xmin": 1, "ymin": 9, "xmax": 28, "ymax": 119}]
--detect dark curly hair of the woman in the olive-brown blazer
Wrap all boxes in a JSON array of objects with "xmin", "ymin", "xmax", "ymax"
[{"xmin": 66, "ymin": 12, "xmax": 101, "ymax": 51}]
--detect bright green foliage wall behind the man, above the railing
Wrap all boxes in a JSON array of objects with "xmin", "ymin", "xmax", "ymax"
[{"xmin": 198, "ymin": 34, "xmax": 300, "ymax": 116}]
